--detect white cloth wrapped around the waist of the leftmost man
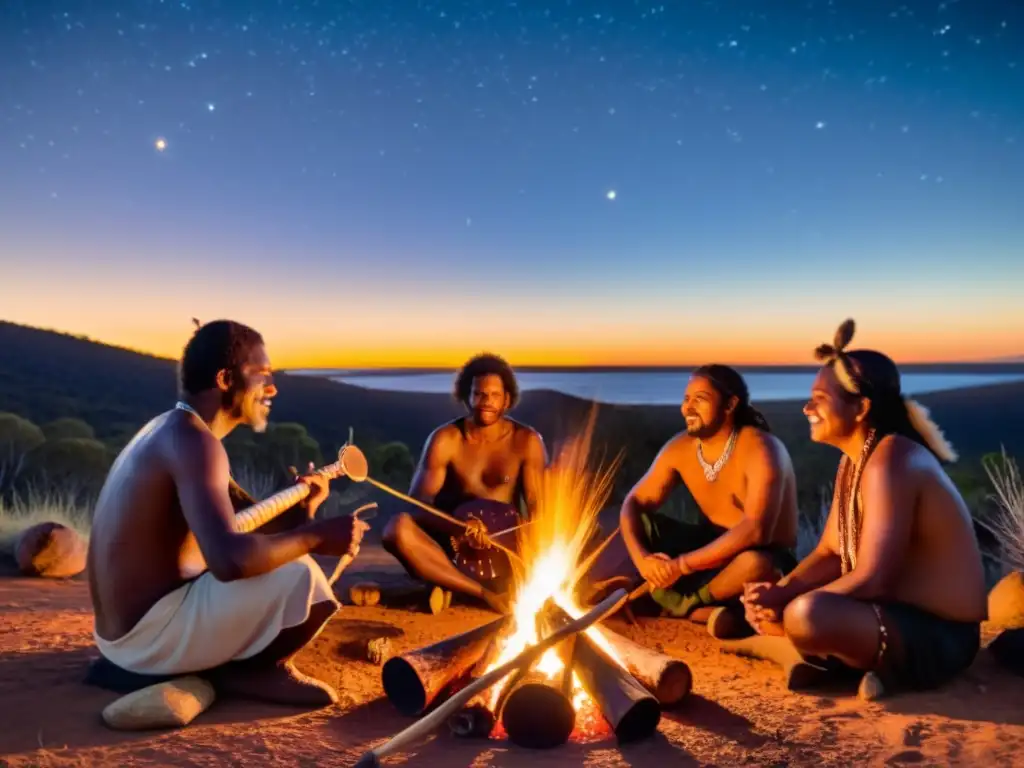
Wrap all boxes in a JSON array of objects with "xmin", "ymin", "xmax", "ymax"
[{"xmin": 93, "ymin": 555, "xmax": 338, "ymax": 675}]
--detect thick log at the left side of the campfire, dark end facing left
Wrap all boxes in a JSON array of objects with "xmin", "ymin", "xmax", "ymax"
[{"xmin": 381, "ymin": 616, "xmax": 509, "ymax": 717}]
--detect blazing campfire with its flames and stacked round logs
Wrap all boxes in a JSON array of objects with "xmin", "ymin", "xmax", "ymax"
[{"xmin": 382, "ymin": 422, "xmax": 691, "ymax": 749}]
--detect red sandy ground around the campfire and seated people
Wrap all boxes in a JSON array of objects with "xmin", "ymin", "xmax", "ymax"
[{"xmin": 0, "ymin": 550, "xmax": 1024, "ymax": 768}]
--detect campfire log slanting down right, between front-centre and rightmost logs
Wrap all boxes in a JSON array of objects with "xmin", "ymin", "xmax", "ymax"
[{"xmin": 548, "ymin": 606, "xmax": 662, "ymax": 741}]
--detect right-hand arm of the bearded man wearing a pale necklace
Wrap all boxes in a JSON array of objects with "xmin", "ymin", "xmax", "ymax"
[{"xmin": 677, "ymin": 433, "xmax": 785, "ymax": 573}]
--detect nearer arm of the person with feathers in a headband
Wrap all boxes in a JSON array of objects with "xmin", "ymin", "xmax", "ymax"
[{"xmin": 817, "ymin": 439, "xmax": 916, "ymax": 600}]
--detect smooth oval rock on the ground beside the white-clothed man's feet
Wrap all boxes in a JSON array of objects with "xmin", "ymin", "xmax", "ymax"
[{"xmin": 103, "ymin": 676, "xmax": 216, "ymax": 731}]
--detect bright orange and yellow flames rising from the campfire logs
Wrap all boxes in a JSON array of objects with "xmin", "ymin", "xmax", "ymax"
[{"xmin": 487, "ymin": 413, "xmax": 623, "ymax": 737}]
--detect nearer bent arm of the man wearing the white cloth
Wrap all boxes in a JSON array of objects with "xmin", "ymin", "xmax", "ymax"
[{"xmin": 169, "ymin": 429, "xmax": 322, "ymax": 582}]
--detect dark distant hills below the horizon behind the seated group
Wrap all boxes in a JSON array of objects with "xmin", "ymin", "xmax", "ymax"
[{"xmin": 0, "ymin": 322, "xmax": 1024, "ymax": 466}]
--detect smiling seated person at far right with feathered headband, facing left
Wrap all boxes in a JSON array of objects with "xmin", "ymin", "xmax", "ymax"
[{"xmin": 743, "ymin": 321, "xmax": 987, "ymax": 697}]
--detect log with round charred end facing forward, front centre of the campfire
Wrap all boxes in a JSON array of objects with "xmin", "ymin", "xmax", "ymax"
[{"xmin": 499, "ymin": 611, "xmax": 577, "ymax": 750}]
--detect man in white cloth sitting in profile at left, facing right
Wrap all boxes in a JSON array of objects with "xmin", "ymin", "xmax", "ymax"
[{"xmin": 88, "ymin": 321, "xmax": 366, "ymax": 707}]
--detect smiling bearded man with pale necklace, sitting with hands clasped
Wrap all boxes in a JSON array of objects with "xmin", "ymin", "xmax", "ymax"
[{"xmin": 598, "ymin": 365, "xmax": 797, "ymax": 638}]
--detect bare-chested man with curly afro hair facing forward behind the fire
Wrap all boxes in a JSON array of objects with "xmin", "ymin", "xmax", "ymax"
[{"xmin": 383, "ymin": 354, "xmax": 547, "ymax": 613}]
